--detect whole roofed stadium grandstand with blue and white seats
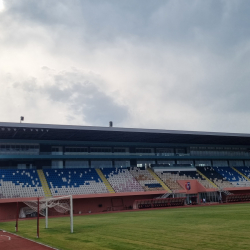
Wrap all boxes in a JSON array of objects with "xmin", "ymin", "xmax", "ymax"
[{"xmin": 0, "ymin": 122, "xmax": 250, "ymax": 220}]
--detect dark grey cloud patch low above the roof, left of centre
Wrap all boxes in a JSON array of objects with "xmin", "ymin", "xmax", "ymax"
[{"xmin": 14, "ymin": 68, "xmax": 129, "ymax": 126}]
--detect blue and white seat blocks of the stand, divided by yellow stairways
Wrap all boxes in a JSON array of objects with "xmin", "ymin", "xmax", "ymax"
[{"xmin": 0, "ymin": 167, "xmax": 250, "ymax": 198}]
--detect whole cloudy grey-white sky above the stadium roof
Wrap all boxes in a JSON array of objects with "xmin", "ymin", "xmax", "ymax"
[{"xmin": 0, "ymin": 0, "xmax": 250, "ymax": 133}]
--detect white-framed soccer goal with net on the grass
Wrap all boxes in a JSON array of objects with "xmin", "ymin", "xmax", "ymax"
[{"xmin": 16, "ymin": 195, "xmax": 73, "ymax": 238}]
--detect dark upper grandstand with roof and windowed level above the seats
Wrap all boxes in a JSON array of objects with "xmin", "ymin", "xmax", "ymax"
[{"xmin": 0, "ymin": 123, "xmax": 250, "ymax": 169}]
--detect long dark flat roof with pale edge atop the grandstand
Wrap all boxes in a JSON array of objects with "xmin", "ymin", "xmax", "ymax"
[{"xmin": 0, "ymin": 122, "xmax": 250, "ymax": 146}]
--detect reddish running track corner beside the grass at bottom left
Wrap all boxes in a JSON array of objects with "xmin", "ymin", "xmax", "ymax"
[{"xmin": 0, "ymin": 231, "xmax": 55, "ymax": 250}]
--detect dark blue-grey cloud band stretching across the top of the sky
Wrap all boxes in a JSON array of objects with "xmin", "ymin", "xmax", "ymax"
[{"xmin": 6, "ymin": 0, "xmax": 250, "ymax": 49}]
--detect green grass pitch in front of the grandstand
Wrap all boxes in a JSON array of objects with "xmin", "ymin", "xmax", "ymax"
[{"xmin": 0, "ymin": 204, "xmax": 250, "ymax": 250}]
